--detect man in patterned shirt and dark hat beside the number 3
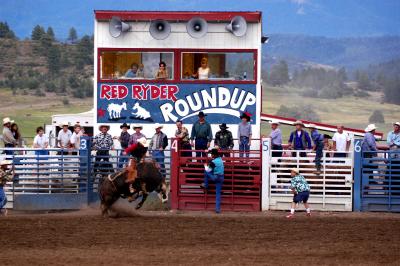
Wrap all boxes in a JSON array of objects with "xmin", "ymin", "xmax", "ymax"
[{"xmin": 93, "ymin": 125, "xmax": 114, "ymax": 173}]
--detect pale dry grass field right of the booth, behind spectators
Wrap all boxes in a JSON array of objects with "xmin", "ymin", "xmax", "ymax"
[{"xmin": 262, "ymin": 85, "xmax": 400, "ymax": 139}]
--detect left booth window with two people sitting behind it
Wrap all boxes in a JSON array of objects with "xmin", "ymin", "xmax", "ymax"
[{"xmin": 100, "ymin": 51, "xmax": 174, "ymax": 79}]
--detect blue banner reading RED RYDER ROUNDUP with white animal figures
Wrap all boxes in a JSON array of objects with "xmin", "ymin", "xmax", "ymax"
[{"xmin": 97, "ymin": 83, "xmax": 257, "ymax": 124}]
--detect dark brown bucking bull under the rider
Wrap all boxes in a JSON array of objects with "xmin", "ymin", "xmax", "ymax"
[{"xmin": 99, "ymin": 161, "xmax": 167, "ymax": 216}]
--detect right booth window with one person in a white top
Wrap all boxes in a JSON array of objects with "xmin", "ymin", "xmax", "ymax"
[{"xmin": 181, "ymin": 52, "xmax": 255, "ymax": 81}]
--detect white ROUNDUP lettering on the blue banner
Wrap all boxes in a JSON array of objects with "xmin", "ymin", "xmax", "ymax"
[{"xmin": 160, "ymin": 87, "xmax": 256, "ymax": 123}]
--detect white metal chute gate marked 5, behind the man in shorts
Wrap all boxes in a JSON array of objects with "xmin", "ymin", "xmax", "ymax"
[{"xmin": 263, "ymin": 139, "xmax": 353, "ymax": 211}]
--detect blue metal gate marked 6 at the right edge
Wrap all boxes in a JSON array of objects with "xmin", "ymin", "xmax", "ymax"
[{"xmin": 354, "ymin": 140, "xmax": 400, "ymax": 212}]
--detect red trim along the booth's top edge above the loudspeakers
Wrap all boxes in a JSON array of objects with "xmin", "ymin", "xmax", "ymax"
[{"xmin": 94, "ymin": 10, "xmax": 261, "ymax": 22}]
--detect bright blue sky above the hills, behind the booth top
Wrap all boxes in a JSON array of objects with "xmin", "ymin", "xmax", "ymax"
[{"xmin": 0, "ymin": 0, "xmax": 400, "ymax": 39}]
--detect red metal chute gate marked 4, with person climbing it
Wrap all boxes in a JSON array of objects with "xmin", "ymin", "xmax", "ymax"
[{"xmin": 171, "ymin": 140, "xmax": 262, "ymax": 211}]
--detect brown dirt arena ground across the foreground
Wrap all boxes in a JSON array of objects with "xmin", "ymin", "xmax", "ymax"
[{"xmin": 0, "ymin": 209, "xmax": 400, "ymax": 265}]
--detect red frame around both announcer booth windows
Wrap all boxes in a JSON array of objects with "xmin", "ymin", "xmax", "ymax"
[{"xmin": 97, "ymin": 47, "xmax": 258, "ymax": 84}]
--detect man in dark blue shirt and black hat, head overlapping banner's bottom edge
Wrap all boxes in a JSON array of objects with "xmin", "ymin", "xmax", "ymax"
[{"xmin": 190, "ymin": 112, "xmax": 213, "ymax": 157}]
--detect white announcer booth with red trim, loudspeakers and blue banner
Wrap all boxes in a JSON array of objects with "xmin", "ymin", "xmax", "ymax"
[{"xmin": 94, "ymin": 11, "xmax": 262, "ymax": 212}]
